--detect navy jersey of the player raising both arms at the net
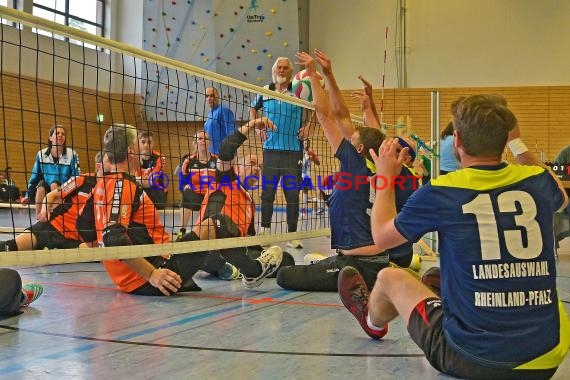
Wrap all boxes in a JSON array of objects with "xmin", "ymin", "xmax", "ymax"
[{"xmin": 329, "ymin": 139, "xmax": 415, "ymax": 252}]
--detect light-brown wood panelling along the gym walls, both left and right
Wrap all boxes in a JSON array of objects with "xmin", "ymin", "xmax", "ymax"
[{"xmin": 0, "ymin": 73, "xmax": 570, "ymax": 208}]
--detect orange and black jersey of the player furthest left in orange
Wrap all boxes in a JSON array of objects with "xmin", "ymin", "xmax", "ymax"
[{"xmin": 49, "ymin": 173, "xmax": 97, "ymax": 242}]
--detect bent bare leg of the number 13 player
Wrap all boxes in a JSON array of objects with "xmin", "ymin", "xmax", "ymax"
[{"xmin": 368, "ymin": 268, "xmax": 437, "ymax": 326}]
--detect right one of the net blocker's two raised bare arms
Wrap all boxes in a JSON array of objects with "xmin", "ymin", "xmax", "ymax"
[{"xmin": 312, "ymin": 49, "xmax": 354, "ymax": 139}]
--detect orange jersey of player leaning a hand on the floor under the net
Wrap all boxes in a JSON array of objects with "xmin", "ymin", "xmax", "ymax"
[{"xmin": 93, "ymin": 173, "xmax": 170, "ymax": 293}]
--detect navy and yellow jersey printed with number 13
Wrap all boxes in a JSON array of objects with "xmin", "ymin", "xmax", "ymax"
[{"xmin": 395, "ymin": 164, "xmax": 570, "ymax": 369}]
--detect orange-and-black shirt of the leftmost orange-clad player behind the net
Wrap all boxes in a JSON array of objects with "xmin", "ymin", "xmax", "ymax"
[{"xmin": 49, "ymin": 173, "xmax": 97, "ymax": 241}]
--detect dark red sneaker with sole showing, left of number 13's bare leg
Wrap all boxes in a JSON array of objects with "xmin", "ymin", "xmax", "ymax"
[{"xmin": 338, "ymin": 266, "xmax": 388, "ymax": 339}]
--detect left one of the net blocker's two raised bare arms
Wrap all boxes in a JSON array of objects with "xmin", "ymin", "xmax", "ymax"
[{"xmin": 296, "ymin": 52, "xmax": 343, "ymax": 153}]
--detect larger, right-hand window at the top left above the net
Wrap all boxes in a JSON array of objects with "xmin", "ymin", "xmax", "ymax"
[{"xmin": 31, "ymin": 0, "xmax": 106, "ymax": 47}]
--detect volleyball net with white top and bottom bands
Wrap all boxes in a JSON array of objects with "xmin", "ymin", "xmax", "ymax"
[{"xmin": 0, "ymin": 7, "xmax": 348, "ymax": 266}]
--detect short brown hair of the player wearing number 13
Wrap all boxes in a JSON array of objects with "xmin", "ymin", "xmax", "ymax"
[{"xmin": 453, "ymin": 94, "xmax": 517, "ymax": 157}]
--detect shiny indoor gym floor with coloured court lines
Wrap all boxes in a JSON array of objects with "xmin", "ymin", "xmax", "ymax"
[{"xmin": 0, "ymin": 206, "xmax": 570, "ymax": 380}]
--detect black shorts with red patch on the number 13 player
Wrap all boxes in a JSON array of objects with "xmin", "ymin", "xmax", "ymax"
[{"xmin": 408, "ymin": 297, "xmax": 556, "ymax": 379}]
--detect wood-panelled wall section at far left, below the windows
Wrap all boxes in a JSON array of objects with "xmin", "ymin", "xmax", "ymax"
[{"xmin": 0, "ymin": 73, "xmax": 140, "ymax": 190}]
